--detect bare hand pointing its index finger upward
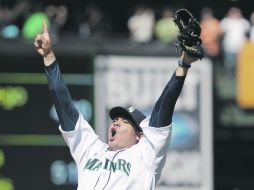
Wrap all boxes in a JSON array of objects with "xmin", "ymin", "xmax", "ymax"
[{"xmin": 34, "ymin": 20, "xmax": 51, "ymax": 57}]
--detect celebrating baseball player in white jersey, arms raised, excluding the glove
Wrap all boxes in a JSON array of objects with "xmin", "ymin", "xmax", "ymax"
[{"xmin": 34, "ymin": 22, "xmax": 198, "ymax": 190}]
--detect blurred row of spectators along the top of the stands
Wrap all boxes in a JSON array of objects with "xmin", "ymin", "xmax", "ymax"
[{"xmin": 0, "ymin": 1, "xmax": 254, "ymax": 81}]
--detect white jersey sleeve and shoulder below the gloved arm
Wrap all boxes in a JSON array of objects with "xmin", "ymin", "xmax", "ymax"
[{"xmin": 137, "ymin": 117, "xmax": 172, "ymax": 181}]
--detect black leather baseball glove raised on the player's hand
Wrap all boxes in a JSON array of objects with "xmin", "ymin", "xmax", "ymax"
[{"xmin": 173, "ymin": 9, "xmax": 204, "ymax": 59}]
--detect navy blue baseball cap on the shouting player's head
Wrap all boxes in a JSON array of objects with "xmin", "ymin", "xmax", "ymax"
[{"xmin": 109, "ymin": 106, "xmax": 146, "ymax": 132}]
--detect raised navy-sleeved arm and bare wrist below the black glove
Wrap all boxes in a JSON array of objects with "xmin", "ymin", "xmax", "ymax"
[{"xmin": 149, "ymin": 51, "xmax": 198, "ymax": 127}]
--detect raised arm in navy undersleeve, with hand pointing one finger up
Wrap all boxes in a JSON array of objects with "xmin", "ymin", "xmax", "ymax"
[{"xmin": 34, "ymin": 21, "xmax": 79, "ymax": 131}]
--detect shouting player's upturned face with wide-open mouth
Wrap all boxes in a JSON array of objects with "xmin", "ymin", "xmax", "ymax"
[{"xmin": 108, "ymin": 117, "xmax": 142, "ymax": 150}]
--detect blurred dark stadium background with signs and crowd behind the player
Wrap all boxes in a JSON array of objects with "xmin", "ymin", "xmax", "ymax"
[{"xmin": 0, "ymin": 0, "xmax": 254, "ymax": 190}]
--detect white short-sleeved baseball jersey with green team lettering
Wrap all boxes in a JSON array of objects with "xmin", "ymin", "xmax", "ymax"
[{"xmin": 59, "ymin": 115, "xmax": 171, "ymax": 190}]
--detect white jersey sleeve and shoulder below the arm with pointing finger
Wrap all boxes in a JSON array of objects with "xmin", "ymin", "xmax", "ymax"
[{"xmin": 59, "ymin": 114, "xmax": 106, "ymax": 164}]
